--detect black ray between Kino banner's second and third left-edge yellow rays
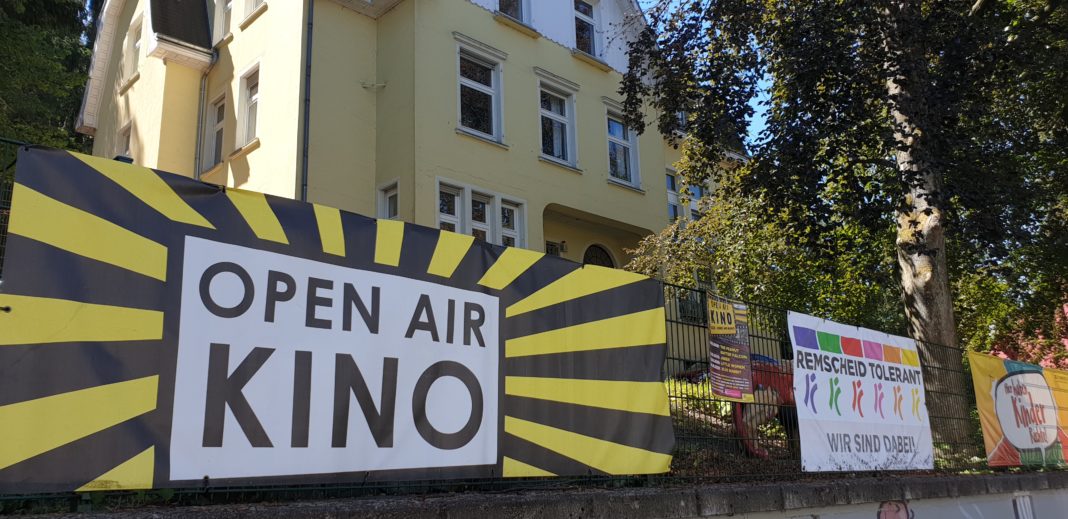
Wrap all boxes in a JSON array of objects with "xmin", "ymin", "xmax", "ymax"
[{"xmin": 0, "ymin": 341, "xmax": 160, "ymax": 406}]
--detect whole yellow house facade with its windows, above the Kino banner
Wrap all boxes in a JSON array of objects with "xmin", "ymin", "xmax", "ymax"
[{"xmin": 79, "ymin": 0, "xmax": 689, "ymax": 267}]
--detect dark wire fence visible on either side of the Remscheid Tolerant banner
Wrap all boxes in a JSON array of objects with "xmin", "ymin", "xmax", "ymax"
[{"xmin": 663, "ymin": 284, "xmax": 986, "ymax": 481}]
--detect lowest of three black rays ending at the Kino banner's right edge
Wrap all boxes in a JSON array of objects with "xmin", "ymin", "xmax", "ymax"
[{"xmin": 503, "ymin": 395, "xmax": 675, "ymax": 454}]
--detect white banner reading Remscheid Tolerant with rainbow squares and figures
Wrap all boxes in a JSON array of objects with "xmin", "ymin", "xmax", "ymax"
[{"xmin": 788, "ymin": 312, "xmax": 935, "ymax": 472}]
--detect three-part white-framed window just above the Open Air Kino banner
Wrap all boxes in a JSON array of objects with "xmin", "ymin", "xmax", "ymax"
[{"xmin": 438, "ymin": 184, "xmax": 524, "ymax": 247}]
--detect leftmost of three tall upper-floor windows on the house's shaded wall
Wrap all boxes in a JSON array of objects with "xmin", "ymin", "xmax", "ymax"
[{"xmin": 459, "ymin": 49, "xmax": 501, "ymax": 141}]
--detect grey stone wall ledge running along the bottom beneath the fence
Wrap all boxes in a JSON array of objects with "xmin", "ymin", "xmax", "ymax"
[{"xmin": 29, "ymin": 472, "xmax": 1068, "ymax": 519}]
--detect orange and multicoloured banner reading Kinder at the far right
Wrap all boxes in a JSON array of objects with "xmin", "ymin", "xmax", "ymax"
[{"xmin": 968, "ymin": 351, "xmax": 1068, "ymax": 467}]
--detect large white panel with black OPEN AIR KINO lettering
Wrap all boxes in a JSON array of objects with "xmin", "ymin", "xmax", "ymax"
[{"xmin": 170, "ymin": 237, "xmax": 499, "ymax": 481}]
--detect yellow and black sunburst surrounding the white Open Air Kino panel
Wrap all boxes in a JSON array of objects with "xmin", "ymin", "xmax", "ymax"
[{"xmin": 0, "ymin": 148, "xmax": 674, "ymax": 493}]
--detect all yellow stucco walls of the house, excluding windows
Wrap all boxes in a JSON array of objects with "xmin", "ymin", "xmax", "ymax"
[{"xmin": 87, "ymin": 0, "xmax": 678, "ymax": 258}]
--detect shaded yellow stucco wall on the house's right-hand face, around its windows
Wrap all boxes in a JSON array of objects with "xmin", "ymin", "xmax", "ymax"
[{"xmin": 403, "ymin": 0, "xmax": 666, "ymax": 250}]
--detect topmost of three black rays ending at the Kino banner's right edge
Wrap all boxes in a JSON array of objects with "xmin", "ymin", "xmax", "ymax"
[{"xmin": 508, "ymin": 280, "xmax": 663, "ymax": 336}]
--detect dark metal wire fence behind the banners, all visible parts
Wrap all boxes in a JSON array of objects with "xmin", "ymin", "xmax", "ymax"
[{"xmin": 0, "ymin": 140, "xmax": 1016, "ymax": 514}]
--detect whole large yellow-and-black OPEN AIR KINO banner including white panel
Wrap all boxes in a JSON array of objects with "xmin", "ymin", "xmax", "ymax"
[{"xmin": 0, "ymin": 148, "xmax": 674, "ymax": 493}]
